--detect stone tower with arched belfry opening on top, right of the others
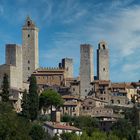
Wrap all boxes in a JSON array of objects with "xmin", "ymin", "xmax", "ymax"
[{"xmin": 97, "ymin": 41, "xmax": 110, "ymax": 80}]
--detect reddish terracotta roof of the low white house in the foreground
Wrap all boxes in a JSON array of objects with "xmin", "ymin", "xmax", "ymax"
[{"xmin": 44, "ymin": 122, "xmax": 81, "ymax": 131}]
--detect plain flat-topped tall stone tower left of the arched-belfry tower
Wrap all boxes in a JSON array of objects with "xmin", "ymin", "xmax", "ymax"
[{"xmin": 80, "ymin": 44, "xmax": 94, "ymax": 98}]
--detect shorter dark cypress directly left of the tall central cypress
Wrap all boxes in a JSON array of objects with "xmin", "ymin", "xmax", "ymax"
[{"xmin": 21, "ymin": 90, "xmax": 29, "ymax": 119}]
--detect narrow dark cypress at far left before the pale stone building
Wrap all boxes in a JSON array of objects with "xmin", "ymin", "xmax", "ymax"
[{"xmin": 1, "ymin": 74, "xmax": 9, "ymax": 102}]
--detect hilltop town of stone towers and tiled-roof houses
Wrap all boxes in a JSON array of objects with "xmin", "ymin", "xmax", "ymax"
[{"xmin": 0, "ymin": 17, "xmax": 140, "ymax": 139}]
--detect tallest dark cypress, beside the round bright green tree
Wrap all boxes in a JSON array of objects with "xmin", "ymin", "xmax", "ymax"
[{"xmin": 29, "ymin": 76, "xmax": 39, "ymax": 121}]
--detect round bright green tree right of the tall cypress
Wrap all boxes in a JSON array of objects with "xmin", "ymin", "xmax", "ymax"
[{"xmin": 40, "ymin": 89, "xmax": 63, "ymax": 111}]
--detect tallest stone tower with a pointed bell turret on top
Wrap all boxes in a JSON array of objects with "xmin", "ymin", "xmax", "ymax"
[{"xmin": 22, "ymin": 17, "xmax": 39, "ymax": 82}]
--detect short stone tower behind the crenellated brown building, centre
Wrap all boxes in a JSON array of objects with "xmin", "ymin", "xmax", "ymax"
[{"xmin": 59, "ymin": 58, "xmax": 73, "ymax": 78}]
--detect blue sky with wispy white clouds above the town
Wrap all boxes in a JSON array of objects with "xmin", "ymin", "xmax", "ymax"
[{"xmin": 0, "ymin": 0, "xmax": 140, "ymax": 82}]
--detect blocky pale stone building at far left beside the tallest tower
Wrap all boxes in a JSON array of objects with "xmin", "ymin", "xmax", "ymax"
[{"xmin": 0, "ymin": 44, "xmax": 22, "ymax": 89}]
